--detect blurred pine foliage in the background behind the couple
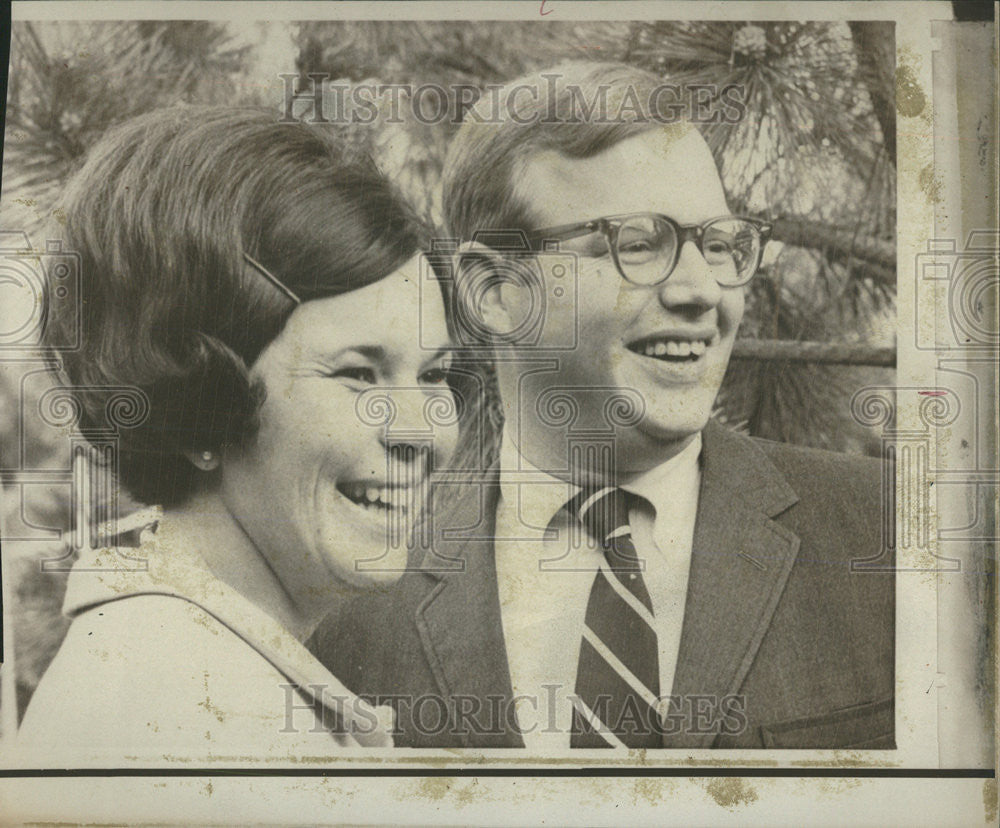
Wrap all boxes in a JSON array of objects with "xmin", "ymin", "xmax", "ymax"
[{"xmin": 0, "ymin": 16, "xmax": 895, "ymax": 720}]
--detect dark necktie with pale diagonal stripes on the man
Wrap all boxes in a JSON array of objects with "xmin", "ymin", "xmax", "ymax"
[{"xmin": 568, "ymin": 487, "xmax": 662, "ymax": 748}]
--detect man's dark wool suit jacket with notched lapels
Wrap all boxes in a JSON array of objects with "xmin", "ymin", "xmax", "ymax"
[{"xmin": 311, "ymin": 423, "xmax": 895, "ymax": 748}]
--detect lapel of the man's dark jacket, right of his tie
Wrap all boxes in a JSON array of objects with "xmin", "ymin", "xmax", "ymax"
[{"xmin": 664, "ymin": 423, "xmax": 799, "ymax": 747}]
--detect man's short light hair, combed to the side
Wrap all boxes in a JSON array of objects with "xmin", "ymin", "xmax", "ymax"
[{"xmin": 442, "ymin": 62, "xmax": 678, "ymax": 241}]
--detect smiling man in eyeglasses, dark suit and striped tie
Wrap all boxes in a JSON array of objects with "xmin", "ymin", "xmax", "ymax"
[{"xmin": 314, "ymin": 64, "xmax": 894, "ymax": 750}]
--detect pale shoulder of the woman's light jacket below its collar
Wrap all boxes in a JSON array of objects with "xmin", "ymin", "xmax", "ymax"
[{"xmin": 19, "ymin": 595, "xmax": 298, "ymax": 755}]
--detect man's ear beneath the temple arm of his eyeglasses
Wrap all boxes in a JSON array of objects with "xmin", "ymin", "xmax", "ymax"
[{"xmin": 454, "ymin": 242, "xmax": 532, "ymax": 344}]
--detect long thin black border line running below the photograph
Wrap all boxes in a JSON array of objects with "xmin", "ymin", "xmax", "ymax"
[{"xmin": 0, "ymin": 766, "xmax": 996, "ymax": 779}]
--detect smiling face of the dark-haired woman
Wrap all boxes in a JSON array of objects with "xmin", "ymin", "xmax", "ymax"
[{"xmin": 221, "ymin": 258, "xmax": 457, "ymax": 604}]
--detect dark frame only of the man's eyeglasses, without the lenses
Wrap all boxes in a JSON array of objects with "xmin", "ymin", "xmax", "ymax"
[{"xmin": 526, "ymin": 212, "xmax": 774, "ymax": 287}]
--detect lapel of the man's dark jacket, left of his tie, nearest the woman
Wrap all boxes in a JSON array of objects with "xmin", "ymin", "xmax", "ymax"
[{"xmin": 416, "ymin": 470, "xmax": 523, "ymax": 747}]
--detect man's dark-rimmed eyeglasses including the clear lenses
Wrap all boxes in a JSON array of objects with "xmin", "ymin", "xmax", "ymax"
[{"xmin": 528, "ymin": 213, "xmax": 771, "ymax": 287}]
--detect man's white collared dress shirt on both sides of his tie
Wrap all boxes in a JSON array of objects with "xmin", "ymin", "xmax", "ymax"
[{"xmin": 496, "ymin": 433, "xmax": 701, "ymax": 751}]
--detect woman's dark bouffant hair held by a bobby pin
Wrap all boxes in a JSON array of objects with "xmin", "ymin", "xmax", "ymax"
[{"xmin": 47, "ymin": 107, "xmax": 421, "ymax": 505}]
